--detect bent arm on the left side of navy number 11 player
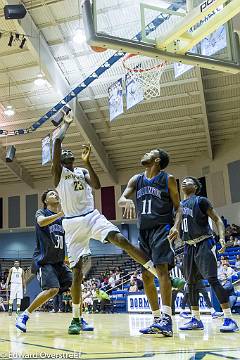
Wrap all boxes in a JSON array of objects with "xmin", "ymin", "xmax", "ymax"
[{"xmin": 118, "ymin": 175, "xmax": 138, "ymax": 219}]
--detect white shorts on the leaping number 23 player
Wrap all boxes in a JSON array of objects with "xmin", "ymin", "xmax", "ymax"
[{"xmin": 63, "ymin": 210, "xmax": 120, "ymax": 268}]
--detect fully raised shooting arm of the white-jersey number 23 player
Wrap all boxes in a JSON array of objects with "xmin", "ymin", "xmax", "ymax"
[{"xmin": 52, "ymin": 115, "xmax": 73, "ymax": 187}]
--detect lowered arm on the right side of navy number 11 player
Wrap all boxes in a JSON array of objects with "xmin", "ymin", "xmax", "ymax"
[{"xmin": 168, "ymin": 175, "xmax": 182, "ymax": 241}]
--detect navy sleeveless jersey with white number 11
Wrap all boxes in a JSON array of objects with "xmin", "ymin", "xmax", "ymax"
[{"xmin": 136, "ymin": 171, "xmax": 173, "ymax": 229}]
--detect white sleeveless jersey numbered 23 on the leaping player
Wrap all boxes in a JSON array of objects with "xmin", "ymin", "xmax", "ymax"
[{"xmin": 56, "ymin": 167, "xmax": 94, "ymax": 217}]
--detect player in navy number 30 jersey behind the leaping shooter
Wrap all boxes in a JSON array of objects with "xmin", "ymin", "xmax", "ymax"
[{"xmin": 16, "ymin": 190, "xmax": 72, "ymax": 332}]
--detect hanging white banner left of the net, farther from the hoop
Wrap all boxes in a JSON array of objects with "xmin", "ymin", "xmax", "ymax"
[{"xmin": 108, "ymin": 79, "xmax": 123, "ymax": 121}]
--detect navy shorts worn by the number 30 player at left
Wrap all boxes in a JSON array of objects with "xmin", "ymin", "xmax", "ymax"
[{"xmin": 38, "ymin": 263, "xmax": 72, "ymax": 293}]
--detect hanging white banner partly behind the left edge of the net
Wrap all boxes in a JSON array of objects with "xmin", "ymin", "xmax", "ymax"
[{"xmin": 125, "ymin": 74, "xmax": 144, "ymax": 110}]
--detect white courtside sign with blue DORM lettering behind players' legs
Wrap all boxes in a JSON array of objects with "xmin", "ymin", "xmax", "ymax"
[{"xmin": 127, "ymin": 291, "xmax": 211, "ymax": 313}]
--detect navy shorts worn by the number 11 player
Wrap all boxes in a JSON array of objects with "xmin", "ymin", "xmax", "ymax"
[{"xmin": 139, "ymin": 225, "xmax": 174, "ymax": 270}]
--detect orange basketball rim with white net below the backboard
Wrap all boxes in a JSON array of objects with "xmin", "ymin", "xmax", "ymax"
[{"xmin": 123, "ymin": 54, "xmax": 168, "ymax": 100}]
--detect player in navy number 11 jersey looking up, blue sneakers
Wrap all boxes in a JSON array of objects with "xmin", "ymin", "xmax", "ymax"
[{"xmin": 119, "ymin": 149, "xmax": 181, "ymax": 336}]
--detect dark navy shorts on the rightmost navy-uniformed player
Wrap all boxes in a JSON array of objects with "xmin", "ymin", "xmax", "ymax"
[{"xmin": 183, "ymin": 238, "xmax": 217, "ymax": 284}]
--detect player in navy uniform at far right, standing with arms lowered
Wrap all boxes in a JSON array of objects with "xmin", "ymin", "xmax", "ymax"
[{"xmin": 180, "ymin": 177, "xmax": 238, "ymax": 332}]
